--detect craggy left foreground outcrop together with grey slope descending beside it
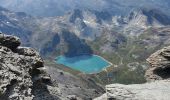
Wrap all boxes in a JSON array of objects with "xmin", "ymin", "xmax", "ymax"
[{"xmin": 0, "ymin": 33, "xmax": 104, "ymax": 100}]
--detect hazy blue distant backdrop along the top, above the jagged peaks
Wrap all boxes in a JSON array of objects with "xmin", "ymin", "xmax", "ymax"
[{"xmin": 0, "ymin": 0, "xmax": 170, "ymax": 16}]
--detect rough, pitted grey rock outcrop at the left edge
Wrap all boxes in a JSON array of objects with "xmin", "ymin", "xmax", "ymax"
[{"xmin": 0, "ymin": 34, "xmax": 43, "ymax": 100}]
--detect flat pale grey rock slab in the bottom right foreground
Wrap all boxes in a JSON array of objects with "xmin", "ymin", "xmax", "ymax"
[{"xmin": 94, "ymin": 80, "xmax": 170, "ymax": 100}]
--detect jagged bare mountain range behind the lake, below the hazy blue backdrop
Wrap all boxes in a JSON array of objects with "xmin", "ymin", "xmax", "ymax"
[{"xmin": 0, "ymin": 8, "xmax": 170, "ymax": 54}]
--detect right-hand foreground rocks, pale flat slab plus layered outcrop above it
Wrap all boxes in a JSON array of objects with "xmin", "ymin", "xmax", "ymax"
[{"xmin": 94, "ymin": 46, "xmax": 170, "ymax": 100}]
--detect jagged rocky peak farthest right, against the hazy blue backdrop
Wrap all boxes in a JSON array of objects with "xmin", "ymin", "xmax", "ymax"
[{"xmin": 127, "ymin": 8, "xmax": 170, "ymax": 26}]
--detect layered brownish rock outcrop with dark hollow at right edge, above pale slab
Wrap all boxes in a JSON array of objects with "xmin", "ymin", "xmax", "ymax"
[{"xmin": 145, "ymin": 46, "xmax": 170, "ymax": 81}]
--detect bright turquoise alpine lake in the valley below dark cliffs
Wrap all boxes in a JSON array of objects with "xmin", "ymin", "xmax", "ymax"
[{"xmin": 55, "ymin": 55, "xmax": 111, "ymax": 74}]
